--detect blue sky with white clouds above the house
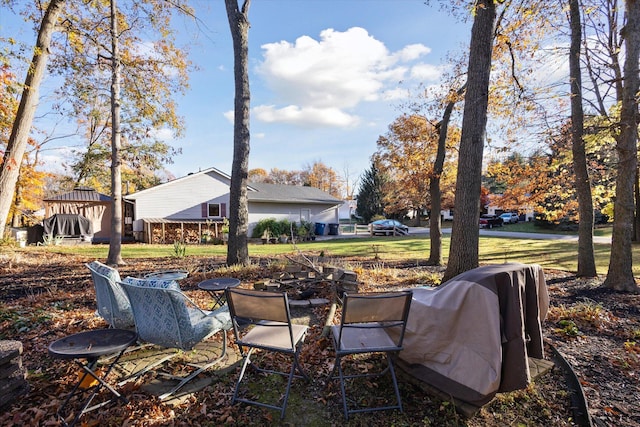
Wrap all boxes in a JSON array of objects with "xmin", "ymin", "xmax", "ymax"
[{"xmin": 0, "ymin": 0, "xmax": 471, "ymax": 186}]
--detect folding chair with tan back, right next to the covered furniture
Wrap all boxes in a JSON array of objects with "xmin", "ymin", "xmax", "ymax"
[{"xmin": 331, "ymin": 291, "xmax": 412, "ymax": 420}]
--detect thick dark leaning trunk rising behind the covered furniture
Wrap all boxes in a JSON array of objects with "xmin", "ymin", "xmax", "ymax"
[{"xmin": 443, "ymin": 0, "xmax": 496, "ymax": 280}]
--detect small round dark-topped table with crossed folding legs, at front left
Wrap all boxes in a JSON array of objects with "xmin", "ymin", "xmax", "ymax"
[{"xmin": 49, "ymin": 329, "xmax": 138, "ymax": 426}]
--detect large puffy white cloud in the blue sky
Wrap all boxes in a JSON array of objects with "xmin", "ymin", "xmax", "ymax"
[{"xmin": 254, "ymin": 27, "xmax": 438, "ymax": 127}]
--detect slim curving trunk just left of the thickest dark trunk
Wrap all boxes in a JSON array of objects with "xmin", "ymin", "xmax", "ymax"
[{"xmin": 427, "ymin": 83, "xmax": 467, "ymax": 265}]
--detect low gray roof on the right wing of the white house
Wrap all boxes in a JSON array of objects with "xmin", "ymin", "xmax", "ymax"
[{"xmin": 247, "ymin": 182, "xmax": 342, "ymax": 205}]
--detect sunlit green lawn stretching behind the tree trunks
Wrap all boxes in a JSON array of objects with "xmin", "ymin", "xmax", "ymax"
[{"xmin": 38, "ymin": 231, "xmax": 640, "ymax": 276}]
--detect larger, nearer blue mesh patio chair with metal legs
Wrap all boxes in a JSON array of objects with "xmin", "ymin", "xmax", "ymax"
[{"xmin": 121, "ymin": 277, "xmax": 231, "ymax": 400}]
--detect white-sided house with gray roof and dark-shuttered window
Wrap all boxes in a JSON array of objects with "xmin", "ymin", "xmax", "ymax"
[{"xmin": 124, "ymin": 168, "xmax": 342, "ymax": 243}]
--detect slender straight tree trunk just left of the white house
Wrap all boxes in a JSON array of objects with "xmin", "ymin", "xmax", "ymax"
[{"xmin": 107, "ymin": 0, "xmax": 124, "ymax": 265}]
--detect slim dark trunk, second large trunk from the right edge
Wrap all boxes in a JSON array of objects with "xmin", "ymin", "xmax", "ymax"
[{"xmin": 569, "ymin": 0, "xmax": 597, "ymax": 277}]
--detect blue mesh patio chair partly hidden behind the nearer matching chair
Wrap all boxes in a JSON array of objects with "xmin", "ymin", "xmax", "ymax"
[{"xmin": 86, "ymin": 261, "xmax": 135, "ymax": 329}]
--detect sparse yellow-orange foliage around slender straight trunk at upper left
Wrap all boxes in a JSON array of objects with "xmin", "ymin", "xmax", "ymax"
[{"xmin": 50, "ymin": 0, "xmax": 190, "ymax": 189}]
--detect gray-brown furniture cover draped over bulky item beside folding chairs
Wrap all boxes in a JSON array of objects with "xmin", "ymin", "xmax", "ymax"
[{"xmin": 398, "ymin": 263, "xmax": 549, "ymax": 406}]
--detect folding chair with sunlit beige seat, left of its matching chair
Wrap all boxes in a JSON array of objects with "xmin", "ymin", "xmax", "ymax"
[{"xmin": 225, "ymin": 288, "xmax": 309, "ymax": 419}]
